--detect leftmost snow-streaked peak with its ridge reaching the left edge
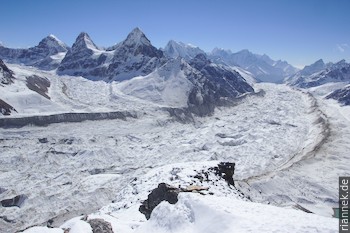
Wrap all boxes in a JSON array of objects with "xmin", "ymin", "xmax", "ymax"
[{"xmin": 0, "ymin": 35, "xmax": 69, "ymax": 70}]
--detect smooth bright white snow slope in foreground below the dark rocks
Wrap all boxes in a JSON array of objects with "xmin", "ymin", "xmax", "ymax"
[{"xmin": 135, "ymin": 194, "xmax": 338, "ymax": 233}]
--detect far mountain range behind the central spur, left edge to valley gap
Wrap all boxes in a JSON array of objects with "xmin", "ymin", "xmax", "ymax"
[{"xmin": 0, "ymin": 28, "xmax": 297, "ymax": 82}]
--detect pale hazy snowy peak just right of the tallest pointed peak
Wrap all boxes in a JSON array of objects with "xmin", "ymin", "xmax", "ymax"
[{"xmin": 164, "ymin": 40, "xmax": 205, "ymax": 61}]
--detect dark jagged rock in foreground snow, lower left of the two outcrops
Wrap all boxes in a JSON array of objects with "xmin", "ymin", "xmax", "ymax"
[{"xmin": 139, "ymin": 183, "xmax": 181, "ymax": 219}]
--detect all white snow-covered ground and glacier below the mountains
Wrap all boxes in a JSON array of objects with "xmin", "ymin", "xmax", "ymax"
[{"xmin": 0, "ymin": 60, "xmax": 350, "ymax": 233}]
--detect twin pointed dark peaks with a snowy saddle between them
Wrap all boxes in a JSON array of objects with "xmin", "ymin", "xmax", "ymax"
[{"xmin": 58, "ymin": 28, "xmax": 165, "ymax": 81}]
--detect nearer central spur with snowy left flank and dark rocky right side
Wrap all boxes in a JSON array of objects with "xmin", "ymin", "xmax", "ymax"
[{"xmin": 120, "ymin": 54, "xmax": 254, "ymax": 116}]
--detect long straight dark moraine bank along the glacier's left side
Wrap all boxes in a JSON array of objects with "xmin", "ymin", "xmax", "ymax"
[{"xmin": 0, "ymin": 111, "xmax": 137, "ymax": 128}]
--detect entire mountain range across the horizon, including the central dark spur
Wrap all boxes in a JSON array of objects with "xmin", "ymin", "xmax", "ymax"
[{"xmin": 0, "ymin": 28, "xmax": 350, "ymax": 109}]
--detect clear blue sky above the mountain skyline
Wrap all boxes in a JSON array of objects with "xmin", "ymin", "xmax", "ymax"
[{"xmin": 0, "ymin": 0, "xmax": 350, "ymax": 67}]
